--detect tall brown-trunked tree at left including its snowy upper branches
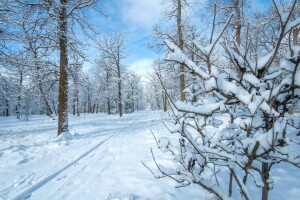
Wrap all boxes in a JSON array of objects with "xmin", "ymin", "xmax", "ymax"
[{"xmin": 16, "ymin": 0, "xmax": 101, "ymax": 135}]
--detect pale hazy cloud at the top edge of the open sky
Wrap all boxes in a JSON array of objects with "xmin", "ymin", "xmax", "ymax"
[{"xmin": 121, "ymin": 0, "xmax": 163, "ymax": 30}]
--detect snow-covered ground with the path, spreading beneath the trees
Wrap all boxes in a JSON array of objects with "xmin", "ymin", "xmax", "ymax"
[{"xmin": 0, "ymin": 111, "xmax": 300, "ymax": 200}]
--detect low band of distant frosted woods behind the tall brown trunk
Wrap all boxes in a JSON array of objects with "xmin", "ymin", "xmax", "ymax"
[{"xmin": 0, "ymin": 40, "xmax": 145, "ymax": 119}]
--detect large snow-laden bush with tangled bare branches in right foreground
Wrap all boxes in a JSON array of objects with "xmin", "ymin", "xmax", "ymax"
[{"xmin": 149, "ymin": 1, "xmax": 300, "ymax": 199}]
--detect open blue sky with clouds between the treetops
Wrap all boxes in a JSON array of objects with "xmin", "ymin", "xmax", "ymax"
[{"xmin": 84, "ymin": 0, "xmax": 272, "ymax": 75}]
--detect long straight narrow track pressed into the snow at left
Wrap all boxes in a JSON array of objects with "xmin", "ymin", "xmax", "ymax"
[{"xmin": 12, "ymin": 133, "xmax": 118, "ymax": 200}]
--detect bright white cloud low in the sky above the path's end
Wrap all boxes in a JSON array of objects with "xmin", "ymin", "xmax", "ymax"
[{"xmin": 129, "ymin": 58, "xmax": 153, "ymax": 77}]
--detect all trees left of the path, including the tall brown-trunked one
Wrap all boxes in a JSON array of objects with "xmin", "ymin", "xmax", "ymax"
[{"xmin": 0, "ymin": 0, "xmax": 144, "ymax": 135}]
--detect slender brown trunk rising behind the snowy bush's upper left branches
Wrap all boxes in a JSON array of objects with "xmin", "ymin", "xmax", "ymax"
[{"xmin": 177, "ymin": 0, "xmax": 185, "ymax": 101}]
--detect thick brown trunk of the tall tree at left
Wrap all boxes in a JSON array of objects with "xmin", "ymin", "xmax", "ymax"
[{"xmin": 57, "ymin": 0, "xmax": 69, "ymax": 135}]
